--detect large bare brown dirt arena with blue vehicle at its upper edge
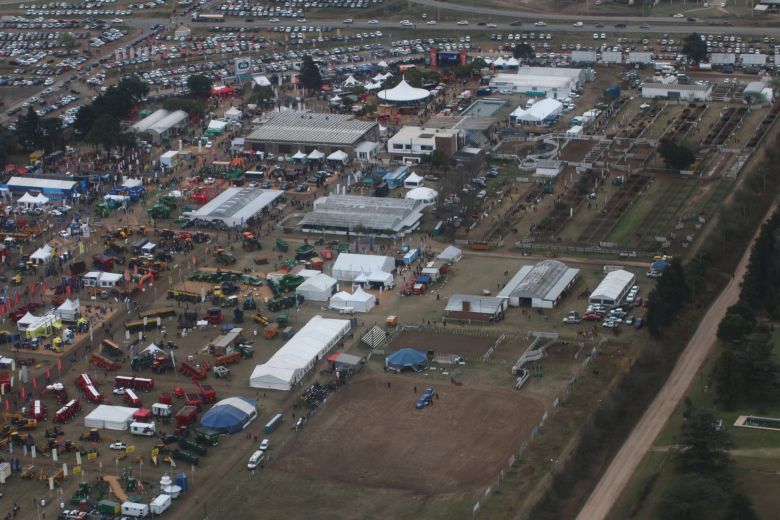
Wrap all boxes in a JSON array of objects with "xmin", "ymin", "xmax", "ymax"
[{"xmin": 272, "ymin": 376, "xmax": 544, "ymax": 495}]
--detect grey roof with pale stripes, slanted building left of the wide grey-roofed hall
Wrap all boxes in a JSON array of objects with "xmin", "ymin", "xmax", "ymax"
[{"xmin": 185, "ymin": 188, "xmax": 284, "ymax": 227}]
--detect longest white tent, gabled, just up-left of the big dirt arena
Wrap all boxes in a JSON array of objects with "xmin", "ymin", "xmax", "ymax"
[{"xmin": 249, "ymin": 316, "xmax": 351, "ymax": 390}]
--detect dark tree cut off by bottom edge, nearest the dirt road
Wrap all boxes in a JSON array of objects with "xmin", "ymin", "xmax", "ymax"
[{"xmin": 658, "ymin": 474, "xmax": 726, "ymax": 520}]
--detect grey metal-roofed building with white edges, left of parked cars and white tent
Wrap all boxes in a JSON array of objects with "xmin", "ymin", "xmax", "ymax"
[{"xmin": 496, "ymin": 260, "xmax": 580, "ymax": 309}]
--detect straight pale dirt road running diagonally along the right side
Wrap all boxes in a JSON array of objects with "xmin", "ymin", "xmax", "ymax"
[{"xmin": 577, "ymin": 204, "xmax": 777, "ymax": 520}]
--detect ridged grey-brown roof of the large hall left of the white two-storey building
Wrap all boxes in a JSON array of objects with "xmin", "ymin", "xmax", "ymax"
[{"xmin": 247, "ymin": 110, "xmax": 377, "ymax": 146}]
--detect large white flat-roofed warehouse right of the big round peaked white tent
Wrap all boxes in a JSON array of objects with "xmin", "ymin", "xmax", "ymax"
[{"xmin": 490, "ymin": 67, "xmax": 588, "ymax": 99}]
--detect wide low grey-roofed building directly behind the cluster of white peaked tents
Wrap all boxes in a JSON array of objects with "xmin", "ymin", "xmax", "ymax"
[{"xmin": 300, "ymin": 195, "xmax": 425, "ymax": 235}]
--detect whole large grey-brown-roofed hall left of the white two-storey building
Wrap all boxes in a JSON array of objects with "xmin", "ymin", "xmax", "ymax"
[{"xmin": 246, "ymin": 110, "xmax": 379, "ymax": 157}]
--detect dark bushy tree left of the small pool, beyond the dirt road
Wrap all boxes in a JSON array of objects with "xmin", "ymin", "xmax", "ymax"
[{"xmin": 675, "ymin": 411, "xmax": 733, "ymax": 483}]
